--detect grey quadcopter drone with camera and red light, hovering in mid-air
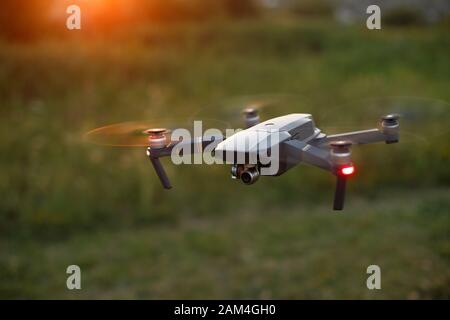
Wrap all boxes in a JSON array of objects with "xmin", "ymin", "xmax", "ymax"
[{"xmin": 130, "ymin": 108, "xmax": 400, "ymax": 210}]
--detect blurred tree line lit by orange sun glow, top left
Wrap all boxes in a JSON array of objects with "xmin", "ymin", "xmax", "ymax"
[{"xmin": 0, "ymin": 0, "xmax": 259, "ymax": 40}]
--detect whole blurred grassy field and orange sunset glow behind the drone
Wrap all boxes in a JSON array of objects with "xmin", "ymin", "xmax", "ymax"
[{"xmin": 0, "ymin": 0, "xmax": 450, "ymax": 299}]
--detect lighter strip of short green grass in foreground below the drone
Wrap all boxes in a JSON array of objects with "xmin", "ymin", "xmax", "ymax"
[{"xmin": 0, "ymin": 189, "xmax": 450, "ymax": 299}]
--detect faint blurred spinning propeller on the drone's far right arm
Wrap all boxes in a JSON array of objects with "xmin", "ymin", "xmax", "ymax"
[{"xmin": 313, "ymin": 96, "xmax": 450, "ymax": 148}]
